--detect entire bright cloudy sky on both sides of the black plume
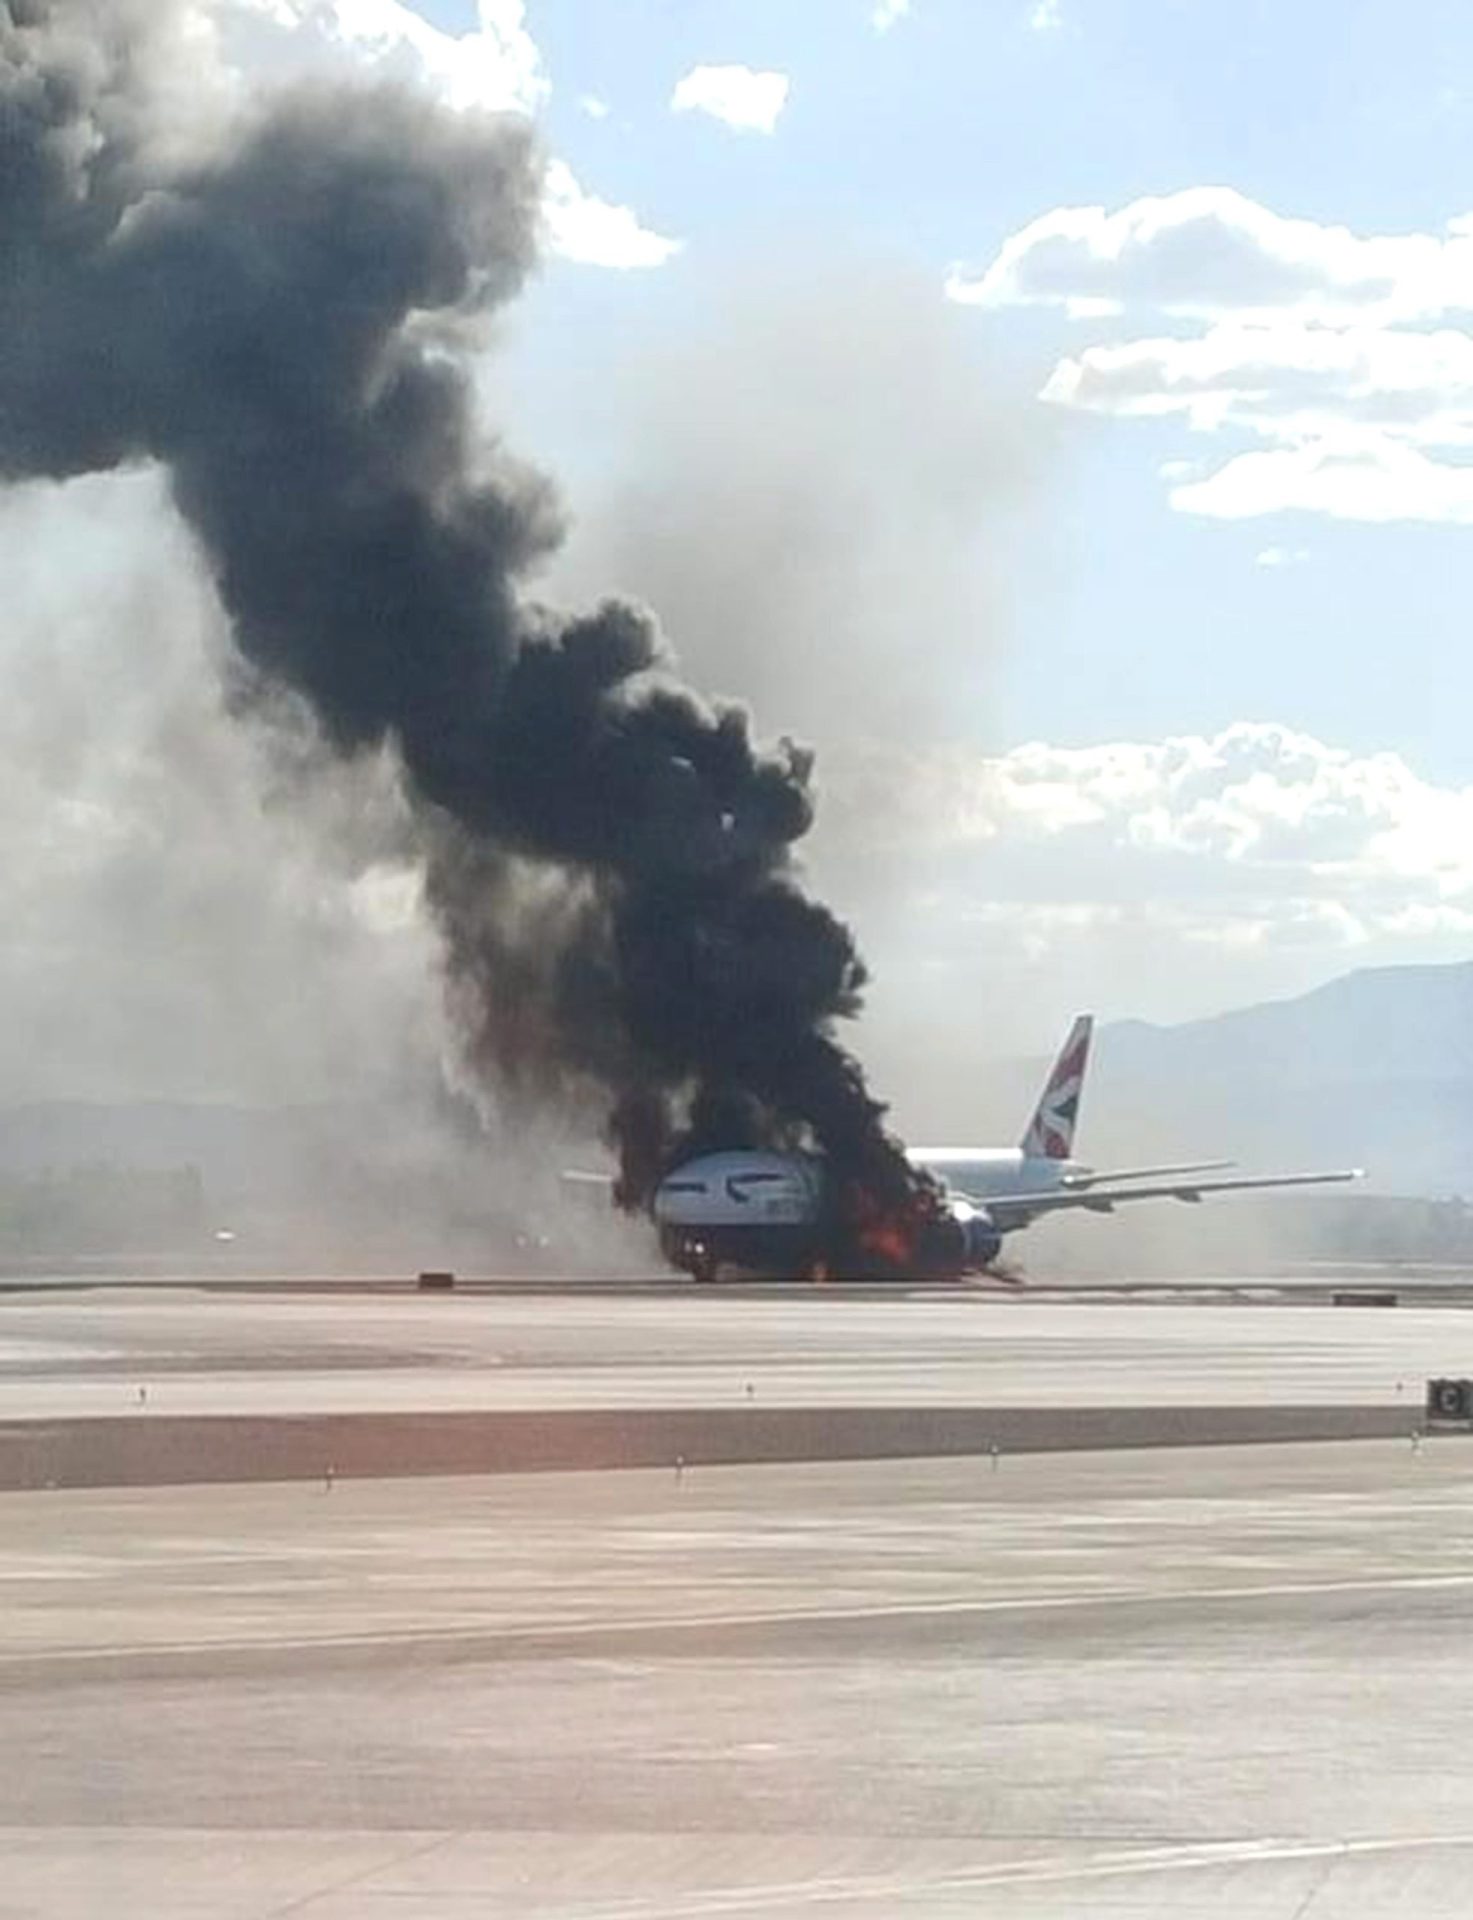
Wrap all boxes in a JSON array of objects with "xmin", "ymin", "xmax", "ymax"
[{"xmin": 0, "ymin": 0, "xmax": 1473, "ymax": 1104}]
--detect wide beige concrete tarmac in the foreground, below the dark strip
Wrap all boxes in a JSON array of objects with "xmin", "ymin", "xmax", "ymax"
[{"xmin": 0, "ymin": 1442, "xmax": 1473, "ymax": 1920}]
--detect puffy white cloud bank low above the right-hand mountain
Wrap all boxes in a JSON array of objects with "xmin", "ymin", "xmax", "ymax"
[{"xmin": 830, "ymin": 722, "xmax": 1473, "ymax": 948}]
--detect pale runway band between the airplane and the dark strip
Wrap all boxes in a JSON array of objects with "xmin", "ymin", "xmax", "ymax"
[{"xmin": 0, "ymin": 1288, "xmax": 1473, "ymax": 1421}]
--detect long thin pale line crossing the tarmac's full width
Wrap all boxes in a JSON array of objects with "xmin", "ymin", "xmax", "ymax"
[{"xmin": 0, "ymin": 1572, "xmax": 1473, "ymax": 1676}]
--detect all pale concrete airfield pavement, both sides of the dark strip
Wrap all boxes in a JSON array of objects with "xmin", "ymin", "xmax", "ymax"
[{"xmin": 0, "ymin": 1288, "xmax": 1473, "ymax": 1920}]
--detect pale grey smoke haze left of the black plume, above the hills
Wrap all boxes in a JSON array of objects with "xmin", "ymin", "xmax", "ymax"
[{"xmin": 0, "ymin": 470, "xmax": 444, "ymax": 1104}]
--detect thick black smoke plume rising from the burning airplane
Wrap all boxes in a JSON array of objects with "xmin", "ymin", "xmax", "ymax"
[{"xmin": 0, "ymin": 0, "xmax": 937, "ymax": 1267}]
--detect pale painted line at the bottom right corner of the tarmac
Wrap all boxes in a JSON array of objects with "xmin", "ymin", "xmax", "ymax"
[{"xmin": 541, "ymin": 1834, "xmax": 1473, "ymax": 1920}]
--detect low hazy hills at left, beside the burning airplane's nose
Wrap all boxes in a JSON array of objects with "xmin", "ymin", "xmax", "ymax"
[{"xmin": 0, "ymin": 1098, "xmax": 649, "ymax": 1271}]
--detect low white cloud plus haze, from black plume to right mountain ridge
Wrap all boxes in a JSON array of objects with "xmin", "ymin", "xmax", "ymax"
[{"xmin": 807, "ymin": 722, "xmax": 1473, "ymax": 1082}]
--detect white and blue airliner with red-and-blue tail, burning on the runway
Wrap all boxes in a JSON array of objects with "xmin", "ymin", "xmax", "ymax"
[{"xmin": 651, "ymin": 1014, "xmax": 1362, "ymax": 1281}]
